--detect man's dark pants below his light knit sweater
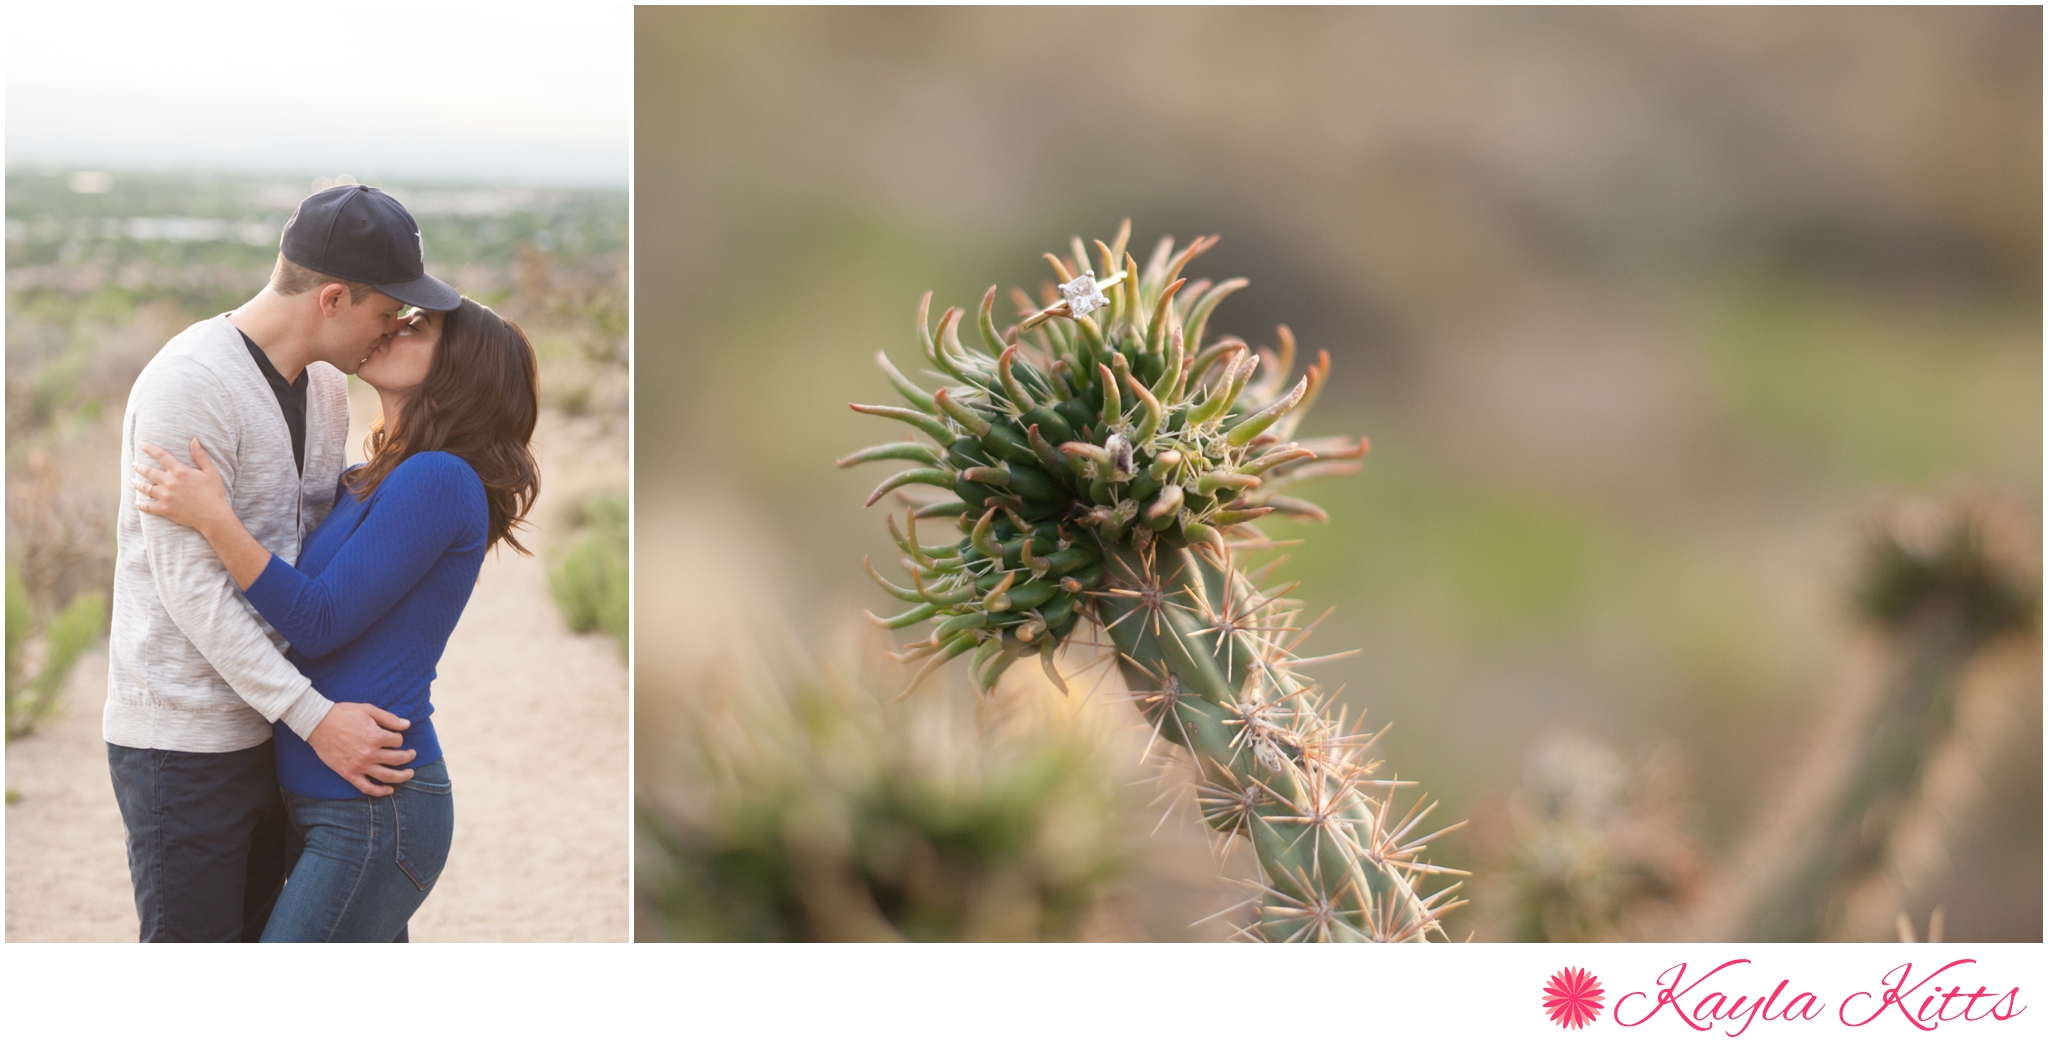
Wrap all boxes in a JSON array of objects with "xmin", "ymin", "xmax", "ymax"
[{"xmin": 106, "ymin": 743, "xmax": 289, "ymax": 942}]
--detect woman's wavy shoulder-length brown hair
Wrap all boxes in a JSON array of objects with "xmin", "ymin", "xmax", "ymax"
[{"xmin": 348, "ymin": 299, "xmax": 541, "ymax": 557}]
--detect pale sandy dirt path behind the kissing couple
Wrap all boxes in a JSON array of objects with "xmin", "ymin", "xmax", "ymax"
[{"xmin": 6, "ymin": 399, "xmax": 631, "ymax": 942}]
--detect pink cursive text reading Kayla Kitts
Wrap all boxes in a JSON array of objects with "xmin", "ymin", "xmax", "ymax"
[{"xmin": 1614, "ymin": 958, "xmax": 2025, "ymax": 1038}]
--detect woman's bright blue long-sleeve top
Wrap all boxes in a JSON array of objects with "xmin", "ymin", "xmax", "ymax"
[{"xmin": 244, "ymin": 450, "xmax": 489, "ymax": 800}]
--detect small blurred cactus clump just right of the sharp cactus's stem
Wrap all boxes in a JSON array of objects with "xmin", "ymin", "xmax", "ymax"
[{"xmin": 1481, "ymin": 735, "xmax": 1704, "ymax": 942}]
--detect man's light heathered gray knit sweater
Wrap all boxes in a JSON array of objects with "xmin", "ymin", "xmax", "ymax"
[{"xmin": 102, "ymin": 315, "xmax": 348, "ymax": 753}]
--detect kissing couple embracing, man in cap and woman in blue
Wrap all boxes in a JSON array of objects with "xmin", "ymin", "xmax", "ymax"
[{"xmin": 102, "ymin": 184, "xmax": 541, "ymax": 942}]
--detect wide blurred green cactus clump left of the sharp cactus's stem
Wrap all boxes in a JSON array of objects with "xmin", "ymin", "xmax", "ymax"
[{"xmin": 639, "ymin": 638, "xmax": 1133, "ymax": 942}]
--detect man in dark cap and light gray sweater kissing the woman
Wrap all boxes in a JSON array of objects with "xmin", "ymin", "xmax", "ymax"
[{"xmin": 102, "ymin": 186, "xmax": 461, "ymax": 942}]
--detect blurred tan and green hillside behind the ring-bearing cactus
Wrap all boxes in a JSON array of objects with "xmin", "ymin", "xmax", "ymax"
[{"xmin": 635, "ymin": 8, "xmax": 2042, "ymax": 940}]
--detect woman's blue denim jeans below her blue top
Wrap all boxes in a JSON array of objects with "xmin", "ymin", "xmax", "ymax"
[{"xmin": 262, "ymin": 761, "xmax": 455, "ymax": 942}]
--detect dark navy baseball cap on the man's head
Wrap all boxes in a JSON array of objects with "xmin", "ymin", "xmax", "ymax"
[{"xmin": 276, "ymin": 186, "xmax": 463, "ymax": 313}]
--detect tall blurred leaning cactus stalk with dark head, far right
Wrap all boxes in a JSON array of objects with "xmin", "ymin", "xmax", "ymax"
[{"xmin": 1700, "ymin": 495, "xmax": 2040, "ymax": 942}]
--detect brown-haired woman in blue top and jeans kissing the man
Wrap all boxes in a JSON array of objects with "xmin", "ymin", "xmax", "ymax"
[{"xmin": 135, "ymin": 299, "xmax": 541, "ymax": 942}]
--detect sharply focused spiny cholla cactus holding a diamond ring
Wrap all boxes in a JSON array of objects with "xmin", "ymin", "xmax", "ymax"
[{"xmin": 840, "ymin": 221, "xmax": 1454, "ymax": 942}]
